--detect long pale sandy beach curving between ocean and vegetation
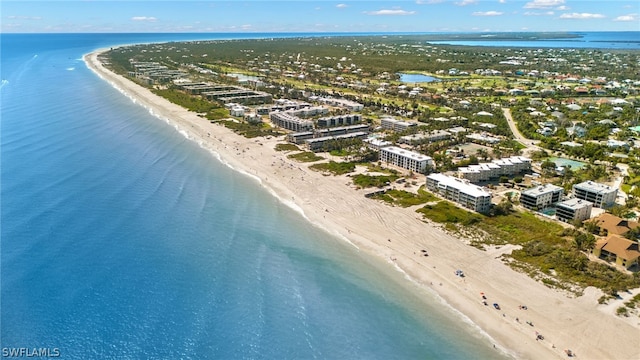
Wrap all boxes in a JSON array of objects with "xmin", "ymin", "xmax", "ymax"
[{"xmin": 83, "ymin": 49, "xmax": 640, "ymax": 359}]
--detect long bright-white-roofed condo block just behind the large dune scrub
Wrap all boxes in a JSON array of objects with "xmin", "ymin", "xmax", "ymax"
[{"xmin": 427, "ymin": 173, "xmax": 491, "ymax": 213}]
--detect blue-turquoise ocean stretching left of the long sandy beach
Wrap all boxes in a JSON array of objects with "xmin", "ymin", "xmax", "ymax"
[{"xmin": 0, "ymin": 34, "xmax": 504, "ymax": 359}]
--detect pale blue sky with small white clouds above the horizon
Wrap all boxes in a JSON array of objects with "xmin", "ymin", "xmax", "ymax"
[{"xmin": 0, "ymin": 0, "xmax": 640, "ymax": 33}]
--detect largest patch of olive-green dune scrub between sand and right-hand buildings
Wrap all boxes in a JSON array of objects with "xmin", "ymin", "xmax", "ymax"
[{"xmin": 412, "ymin": 201, "xmax": 640, "ymax": 294}]
